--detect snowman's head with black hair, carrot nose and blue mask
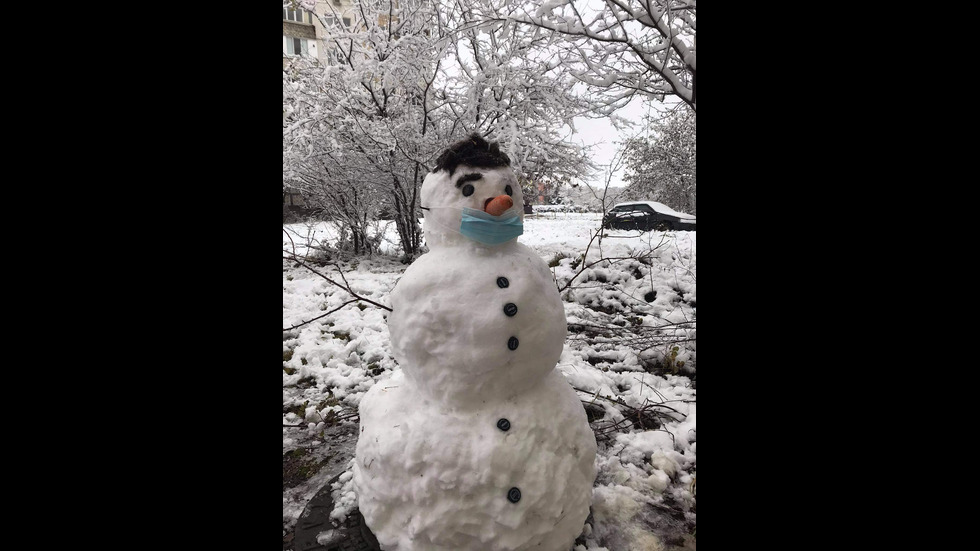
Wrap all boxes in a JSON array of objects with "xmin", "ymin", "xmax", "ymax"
[{"xmin": 422, "ymin": 134, "xmax": 524, "ymax": 247}]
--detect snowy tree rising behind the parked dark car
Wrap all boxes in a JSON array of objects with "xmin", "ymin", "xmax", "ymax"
[{"xmin": 624, "ymin": 106, "xmax": 697, "ymax": 215}]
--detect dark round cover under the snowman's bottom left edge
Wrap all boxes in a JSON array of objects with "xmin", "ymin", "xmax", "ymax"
[{"xmin": 292, "ymin": 474, "xmax": 381, "ymax": 551}]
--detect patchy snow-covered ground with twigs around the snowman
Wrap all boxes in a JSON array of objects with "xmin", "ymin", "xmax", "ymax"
[{"xmin": 282, "ymin": 212, "xmax": 697, "ymax": 551}]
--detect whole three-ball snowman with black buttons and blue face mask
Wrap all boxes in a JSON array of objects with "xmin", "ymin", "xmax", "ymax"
[{"xmin": 354, "ymin": 135, "xmax": 596, "ymax": 551}]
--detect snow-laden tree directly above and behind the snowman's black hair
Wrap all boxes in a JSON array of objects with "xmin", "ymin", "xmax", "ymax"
[{"xmin": 442, "ymin": 0, "xmax": 592, "ymax": 185}]
